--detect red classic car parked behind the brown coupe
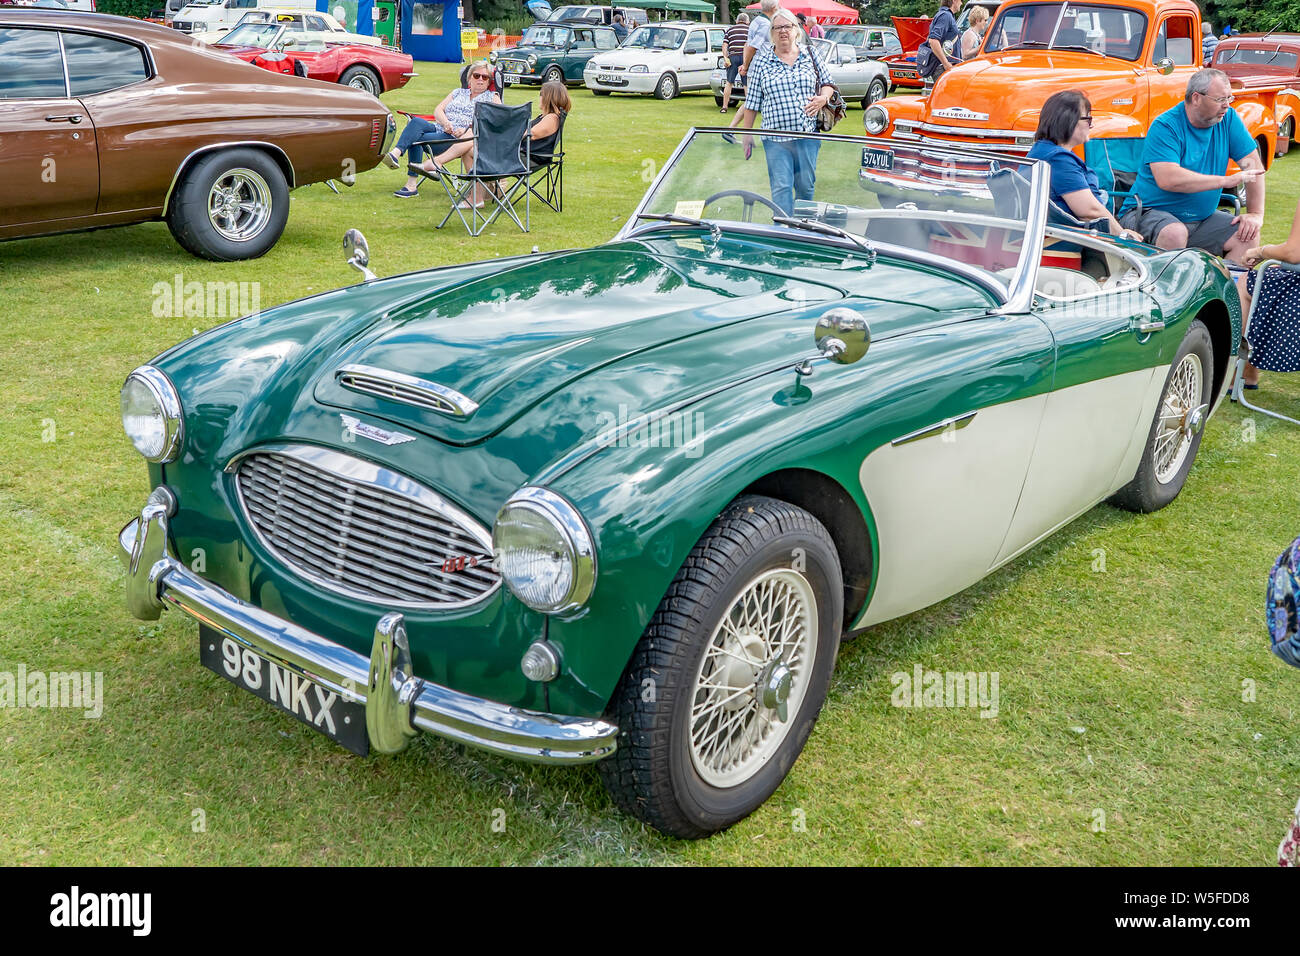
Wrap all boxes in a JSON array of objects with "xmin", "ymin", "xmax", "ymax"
[{"xmin": 213, "ymin": 23, "xmax": 415, "ymax": 96}]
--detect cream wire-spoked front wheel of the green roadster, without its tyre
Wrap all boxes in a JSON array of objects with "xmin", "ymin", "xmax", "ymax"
[{"xmin": 690, "ymin": 568, "xmax": 818, "ymax": 788}]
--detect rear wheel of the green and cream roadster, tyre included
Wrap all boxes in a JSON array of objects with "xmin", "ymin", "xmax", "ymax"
[{"xmin": 1112, "ymin": 319, "xmax": 1214, "ymax": 512}]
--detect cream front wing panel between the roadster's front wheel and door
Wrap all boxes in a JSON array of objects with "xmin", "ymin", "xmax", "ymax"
[{"xmin": 855, "ymin": 394, "xmax": 1048, "ymax": 627}]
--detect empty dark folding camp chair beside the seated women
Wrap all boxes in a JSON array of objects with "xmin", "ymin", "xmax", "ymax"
[{"xmin": 438, "ymin": 103, "xmax": 533, "ymax": 235}]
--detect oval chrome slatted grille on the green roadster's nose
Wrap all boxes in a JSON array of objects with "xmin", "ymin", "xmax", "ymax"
[{"xmin": 231, "ymin": 446, "xmax": 501, "ymax": 609}]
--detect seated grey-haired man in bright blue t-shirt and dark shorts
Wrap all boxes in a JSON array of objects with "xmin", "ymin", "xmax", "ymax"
[{"xmin": 1119, "ymin": 69, "xmax": 1264, "ymax": 261}]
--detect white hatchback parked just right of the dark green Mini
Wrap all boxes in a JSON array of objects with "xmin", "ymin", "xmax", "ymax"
[{"xmin": 582, "ymin": 21, "xmax": 727, "ymax": 100}]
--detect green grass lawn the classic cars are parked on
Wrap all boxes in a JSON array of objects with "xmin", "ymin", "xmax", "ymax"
[{"xmin": 0, "ymin": 64, "xmax": 1300, "ymax": 865}]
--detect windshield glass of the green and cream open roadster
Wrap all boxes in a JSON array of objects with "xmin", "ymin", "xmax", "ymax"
[{"xmin": 625, "ymin": 130, "xmax": 1048, "ymax": 293}]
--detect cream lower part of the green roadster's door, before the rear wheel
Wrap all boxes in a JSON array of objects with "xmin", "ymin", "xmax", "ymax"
[{"xmin": 985, "ymin": 367, "xmax": 1167, "ymax": 571}]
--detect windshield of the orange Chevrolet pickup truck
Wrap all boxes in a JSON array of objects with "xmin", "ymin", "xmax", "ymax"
[{"xmin": 984, "ymin": 3, "xmax": 1147, "ymax": 61}]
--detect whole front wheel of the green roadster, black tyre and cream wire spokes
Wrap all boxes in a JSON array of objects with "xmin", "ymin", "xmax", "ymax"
[{"xmin": 597, "ymin": 496, "xmax": 844, "ymax": 839}]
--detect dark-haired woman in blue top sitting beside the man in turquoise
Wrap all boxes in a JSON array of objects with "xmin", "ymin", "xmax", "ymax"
[{"xmin": 1028, "ymin": 90, "xmax": 1141, "ymax": 241}]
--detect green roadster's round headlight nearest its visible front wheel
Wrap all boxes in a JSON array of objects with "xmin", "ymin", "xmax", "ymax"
[{"xmin": 491, "ymin": 488, "xmax": 595, "ymax": 614}]
